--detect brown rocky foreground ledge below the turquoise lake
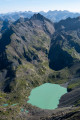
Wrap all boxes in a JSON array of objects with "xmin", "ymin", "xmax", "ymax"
[{"xmin": 20, "ymin": 107, "xmax": 80, "ymax": 120}]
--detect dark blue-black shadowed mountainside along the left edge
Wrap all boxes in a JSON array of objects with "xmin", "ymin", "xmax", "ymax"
[{"xmin": 0, "ymin": 28, "xmax": 15, "ymax": 92}]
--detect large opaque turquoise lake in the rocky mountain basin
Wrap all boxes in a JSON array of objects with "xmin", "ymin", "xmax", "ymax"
[{"xmin": 27, "ymin": 83, "xmax": 67, "ymax": 109}]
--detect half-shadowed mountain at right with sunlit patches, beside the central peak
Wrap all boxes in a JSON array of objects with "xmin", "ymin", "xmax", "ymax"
[{"xmin": 49, "ymin": 17, "xmax": 80, "ymax": 70}]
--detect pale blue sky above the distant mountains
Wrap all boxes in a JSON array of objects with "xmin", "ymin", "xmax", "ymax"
[{"xmin": 0, "ymin": 0, "xmax": 80, "ymax": 13}]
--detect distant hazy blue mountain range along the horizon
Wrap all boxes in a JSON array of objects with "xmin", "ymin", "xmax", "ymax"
[{"xmin": 0, "ymin": 10, "xmax": 80, "ymax": 22}]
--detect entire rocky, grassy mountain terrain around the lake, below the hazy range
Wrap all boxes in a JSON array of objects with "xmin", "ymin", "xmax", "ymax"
[{"xmin": 0, "ymin": 14, "xmax": 80, "ymax": 120}]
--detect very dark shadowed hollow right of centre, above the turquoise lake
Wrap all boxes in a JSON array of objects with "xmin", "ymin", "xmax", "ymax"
[{"xmin": 48, "ymin": 45, "xmax": 73, "ymax": 71}]
